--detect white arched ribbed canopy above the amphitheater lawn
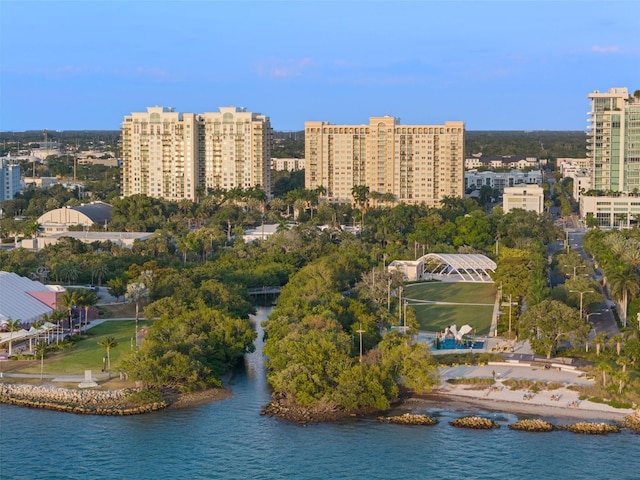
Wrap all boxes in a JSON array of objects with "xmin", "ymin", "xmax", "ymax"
[{"xmin": 420, "ymin": 253, "xmax": 496, "ymax": 282}]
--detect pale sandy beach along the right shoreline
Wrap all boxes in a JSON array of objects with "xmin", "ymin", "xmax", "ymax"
[{"xmin": 420, "ymin": 362, "xmax": 633, "ymax": 421}]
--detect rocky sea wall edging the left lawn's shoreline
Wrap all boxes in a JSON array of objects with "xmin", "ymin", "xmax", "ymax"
[{"xmin": 0, "ymin": 383, "xmax": 167, "ymax": 416}]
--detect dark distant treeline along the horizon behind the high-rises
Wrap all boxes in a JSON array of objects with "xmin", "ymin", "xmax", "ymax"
[{"xmin": 0, "ymin": 130, "xmax": 587, "ymax": 158}]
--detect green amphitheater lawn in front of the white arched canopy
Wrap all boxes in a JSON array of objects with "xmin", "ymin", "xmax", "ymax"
[{"xmin": 404, "ymin": 282, "xmax": 496, "ymax": 335}]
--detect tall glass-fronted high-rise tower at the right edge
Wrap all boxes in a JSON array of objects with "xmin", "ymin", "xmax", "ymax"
[{"xmin": 587, "ymin": 88, "xmax": 640, "ymax": 192}]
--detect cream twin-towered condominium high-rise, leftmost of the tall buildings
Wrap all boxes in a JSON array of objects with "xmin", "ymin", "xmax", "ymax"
[{"xmin": 122, "ymin": 107, "xmax": 273, "ymax": 200}]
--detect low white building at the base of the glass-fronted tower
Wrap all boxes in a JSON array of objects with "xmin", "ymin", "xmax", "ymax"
[{"xmin": 580, "ymin": 194, "xmax": 640, "ymax": 229}]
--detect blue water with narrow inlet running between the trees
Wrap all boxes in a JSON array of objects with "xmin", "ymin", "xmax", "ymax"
[{"xmin": 0, "ymin": 309, "xmax": 640, "ymax": 480}]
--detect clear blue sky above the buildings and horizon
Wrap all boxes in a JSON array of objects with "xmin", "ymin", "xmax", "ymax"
[{"xmin": 0, "ymin": 0, "xmax": 640, "ymax": 131}]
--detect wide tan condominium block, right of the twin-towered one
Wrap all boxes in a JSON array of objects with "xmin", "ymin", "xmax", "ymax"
[{"xmin": 305, "ymin": 116, "xmax": 464, "ymax": 206}]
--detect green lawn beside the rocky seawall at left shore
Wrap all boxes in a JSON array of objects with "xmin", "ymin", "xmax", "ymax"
[{"xmin": 19, "ymin": 320, "xmax": 148, "ymax": 375}]
